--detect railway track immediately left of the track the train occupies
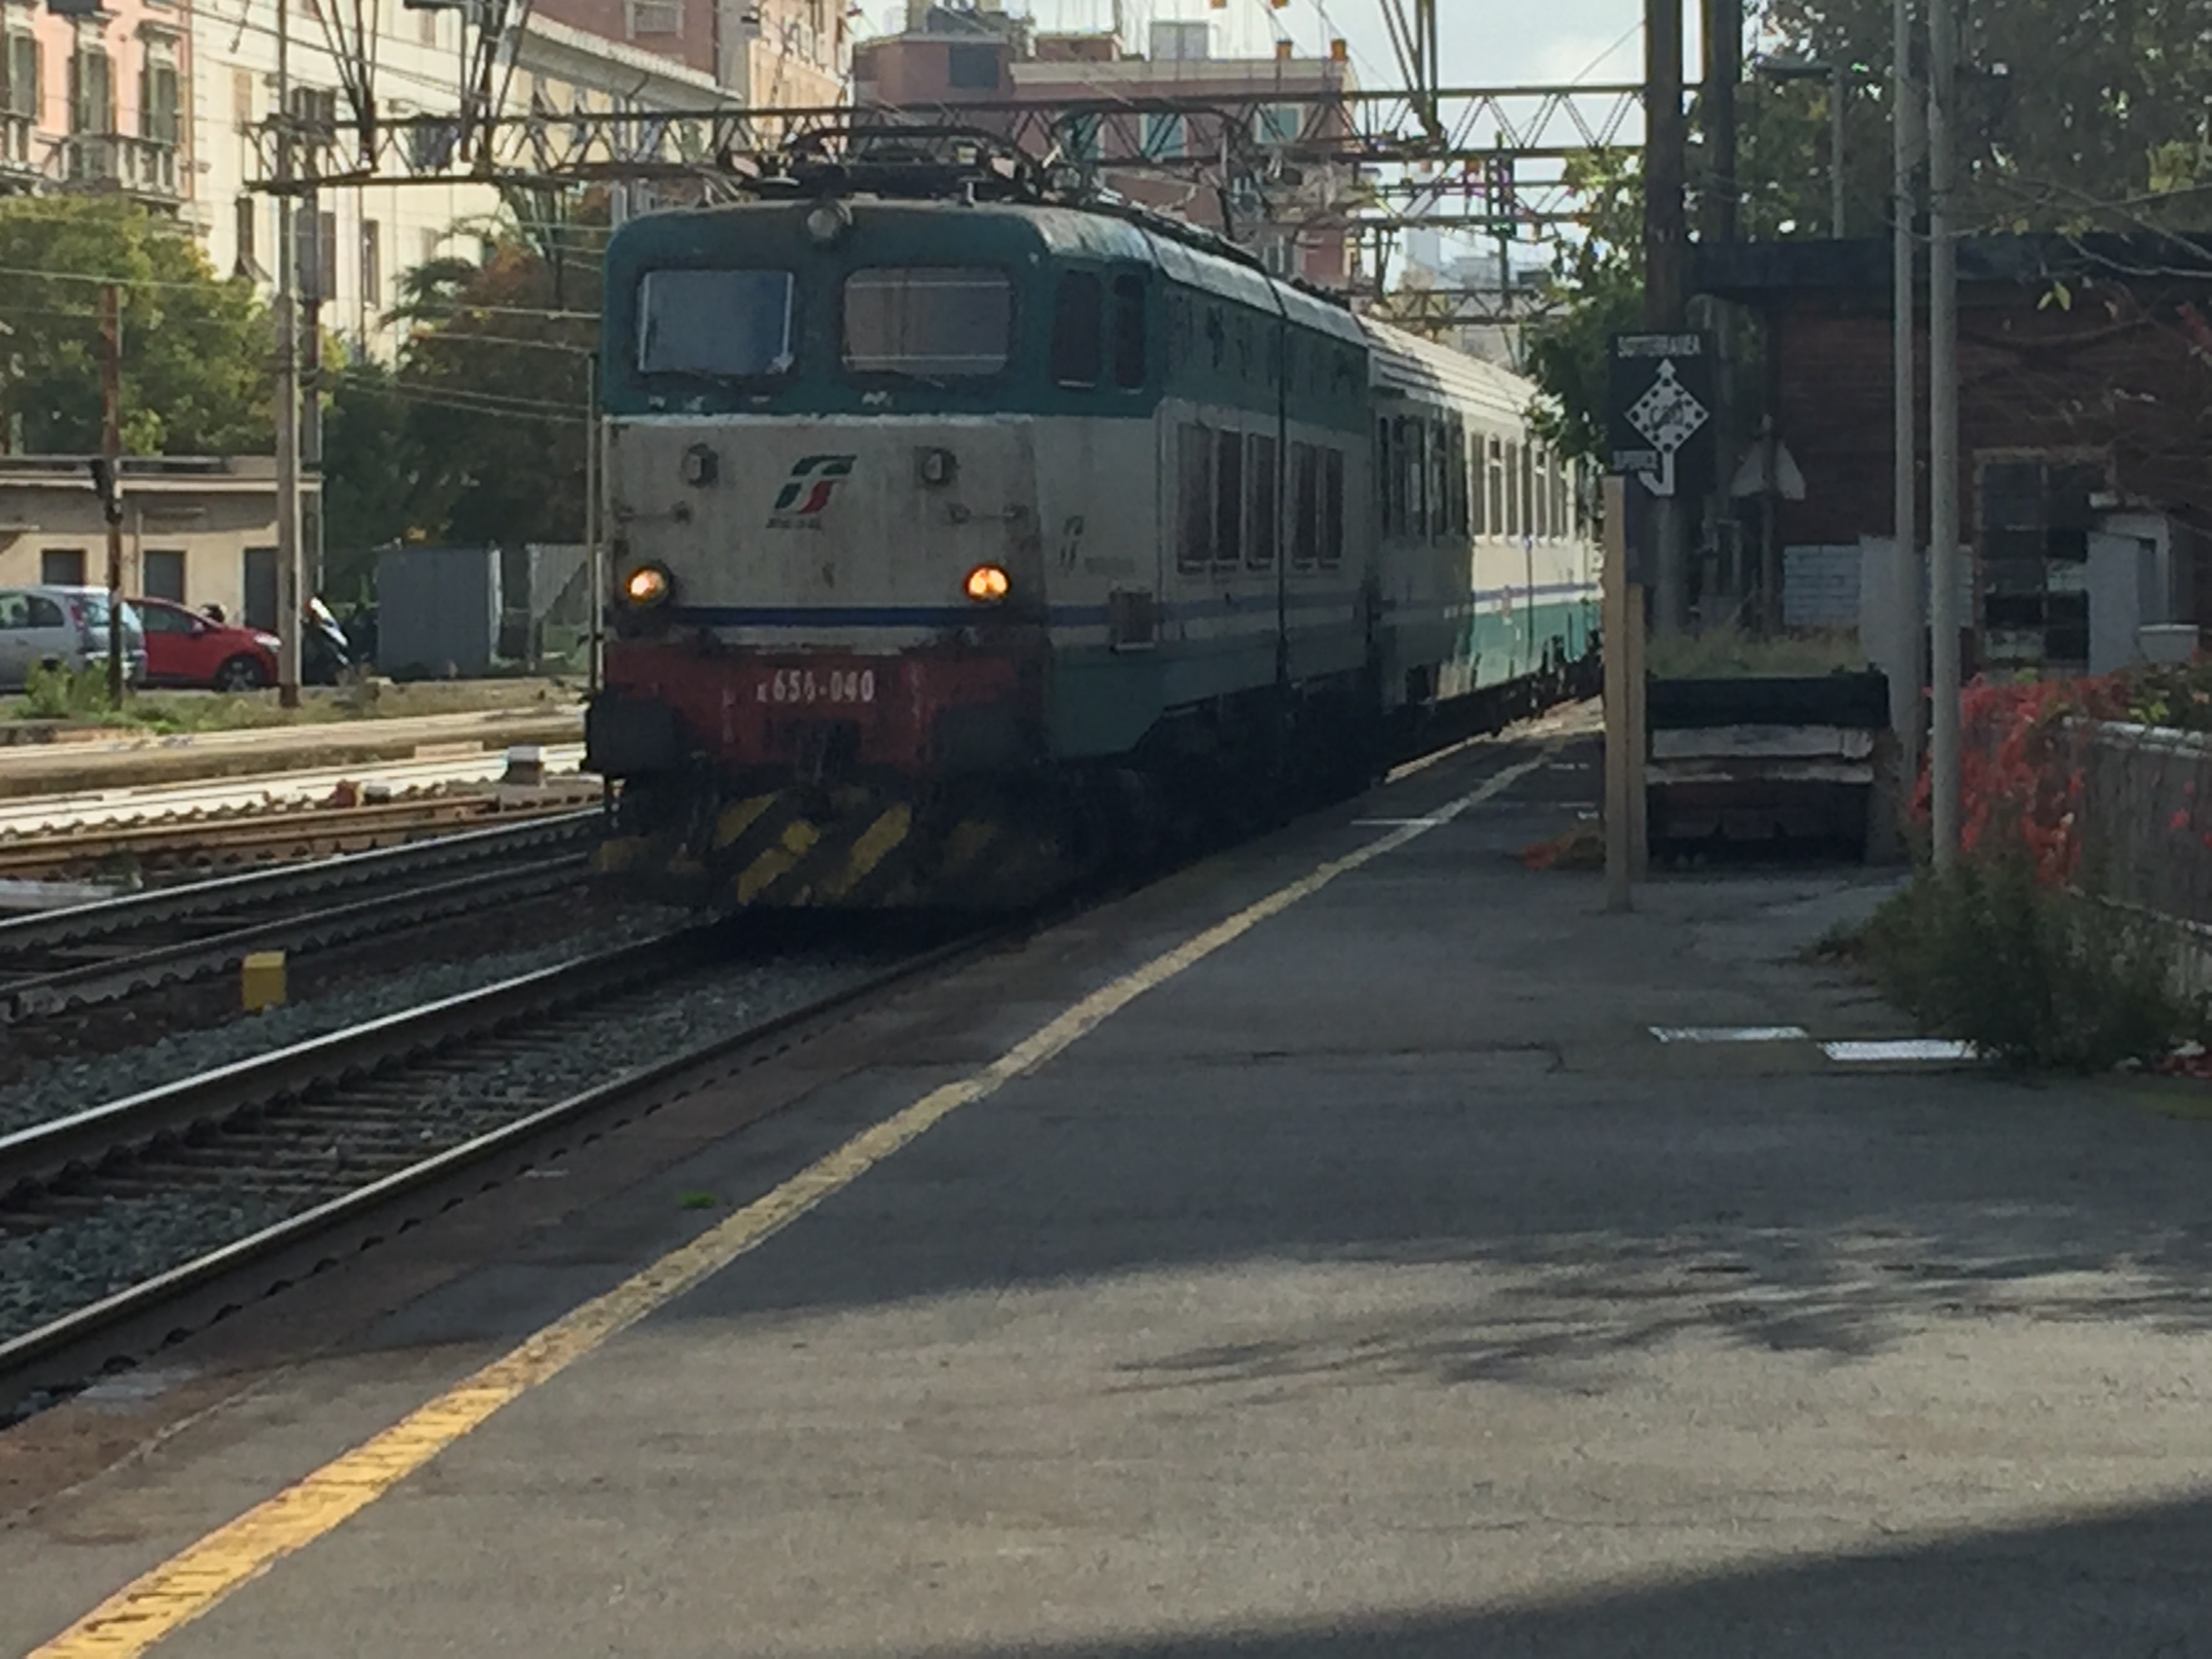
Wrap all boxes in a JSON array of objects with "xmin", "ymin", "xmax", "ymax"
[{"xmin": 0, "ymin": 807, "xmax": 600, "ymax": 1024}]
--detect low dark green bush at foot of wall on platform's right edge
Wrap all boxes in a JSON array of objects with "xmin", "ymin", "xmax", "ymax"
[{"xmin": 1860, "ymin": 849, "xmax": 2207, "ymax": 1073}]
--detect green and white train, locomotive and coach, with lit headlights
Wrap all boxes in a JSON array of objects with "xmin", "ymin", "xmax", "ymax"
[{"xmin": 588, "ymin": 172, "xmax": 1597, "ymax": 907}]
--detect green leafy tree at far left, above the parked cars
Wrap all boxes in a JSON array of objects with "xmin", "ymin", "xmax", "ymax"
[{"xmin": 0, "ymin": 197, "xmax": 274, "ymax": 455}]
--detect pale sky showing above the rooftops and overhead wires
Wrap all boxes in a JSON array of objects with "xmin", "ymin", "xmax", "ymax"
[{"xmin": 863, "ymin": 0, "xmax": 1663, "ymax": 86}]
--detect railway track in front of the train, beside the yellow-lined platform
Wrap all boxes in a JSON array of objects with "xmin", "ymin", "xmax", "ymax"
[{"xmin": 0, "ymin": 924, "xmax": 980, "ymax": 1420}]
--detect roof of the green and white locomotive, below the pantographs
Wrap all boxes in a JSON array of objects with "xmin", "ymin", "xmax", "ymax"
[{"xmin": 606, "ymin": 194, "xmax": 1367, "ymax": 345}]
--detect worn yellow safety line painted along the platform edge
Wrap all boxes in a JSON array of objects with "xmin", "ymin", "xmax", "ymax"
[{"xmin": 28, "ymin": 745, "xmax": 1553, "ymax": 1659}]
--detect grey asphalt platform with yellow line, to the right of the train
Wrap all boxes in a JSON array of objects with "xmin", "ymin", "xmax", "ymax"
[{"xmin": 0, "ymin": 716, "xmax": 2212, "ymax": 1659}]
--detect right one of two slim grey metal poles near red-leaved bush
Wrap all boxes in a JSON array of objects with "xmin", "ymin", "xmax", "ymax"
[{"xmin": 1929, "ymin": 0, "xmax": 1960, "ymax": 869}]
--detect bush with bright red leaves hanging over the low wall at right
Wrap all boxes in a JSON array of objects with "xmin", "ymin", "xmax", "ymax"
[{"xmin": 1913, "ymin": 677, "xmax": 2128, "ymax": 887}]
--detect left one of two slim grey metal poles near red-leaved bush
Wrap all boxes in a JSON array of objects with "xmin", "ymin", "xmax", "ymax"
[{"xmin": 1889, "ymin": 0, "xmax": 1927, "ymax": 818}]
